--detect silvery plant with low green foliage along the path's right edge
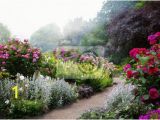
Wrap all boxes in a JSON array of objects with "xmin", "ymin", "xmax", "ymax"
[{"xmin": 80, "ymin": 84, "xmax": 152, "ymax": 119}]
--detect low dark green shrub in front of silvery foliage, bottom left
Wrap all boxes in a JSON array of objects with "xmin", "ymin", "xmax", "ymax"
[{"xmin": 10, "ymin": 100, "xmax": 43, "ymax": 118}]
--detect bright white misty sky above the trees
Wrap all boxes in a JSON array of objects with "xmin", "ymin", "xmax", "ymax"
[{"xmin": 0, "ymin": 0, "xmax": 104, "ymax": 39}]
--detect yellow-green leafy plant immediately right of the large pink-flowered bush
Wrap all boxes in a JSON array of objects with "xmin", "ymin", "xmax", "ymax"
[{"xmin": 40, "ymin": 53, "xmax": 56, "ymax": 78}]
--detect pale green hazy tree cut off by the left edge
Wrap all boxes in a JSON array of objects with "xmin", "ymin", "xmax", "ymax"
[{"xmin": 0, "ymin": 23, "xmax": 11, "ymax": 42}]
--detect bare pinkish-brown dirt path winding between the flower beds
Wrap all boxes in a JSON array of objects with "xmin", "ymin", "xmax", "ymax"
[{"xmin": 39, "ymin": 78, "xmax": 123, "ymax": 119}]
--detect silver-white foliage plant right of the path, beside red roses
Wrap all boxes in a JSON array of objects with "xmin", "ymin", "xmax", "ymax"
[{"xmin": 105, "ymin": 83, "xmax": 135, "ymax": 110}]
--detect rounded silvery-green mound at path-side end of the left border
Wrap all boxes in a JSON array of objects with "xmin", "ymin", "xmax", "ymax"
[{"xmin": 49, "ymin": 80, "xmax": 78, "ymax": 108}]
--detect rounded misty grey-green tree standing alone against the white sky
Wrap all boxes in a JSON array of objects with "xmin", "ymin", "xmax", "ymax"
[{"xmin": 30, "ymin": 24, "xmax": 62, "ymax": 51}]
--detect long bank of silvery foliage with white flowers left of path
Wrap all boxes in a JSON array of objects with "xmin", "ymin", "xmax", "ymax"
[{"xmin": 0, "ymin": 74, "xmax": 77, "ymax": 107}]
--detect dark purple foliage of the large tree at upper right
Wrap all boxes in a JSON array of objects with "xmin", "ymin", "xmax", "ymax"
[{"xmin": 106, "ymin": 1, "xmax": 160, "ymax": 63}]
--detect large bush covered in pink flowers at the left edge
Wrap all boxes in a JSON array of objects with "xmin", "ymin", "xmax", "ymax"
[{"xmin": 0, "ymin": 39, "xmax": 41, "ymax": 76}]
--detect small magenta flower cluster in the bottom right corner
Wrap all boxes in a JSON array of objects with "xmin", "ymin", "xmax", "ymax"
[{"xmin": 139, "ymin": 109, "xmax": 160, "ymax": 120}]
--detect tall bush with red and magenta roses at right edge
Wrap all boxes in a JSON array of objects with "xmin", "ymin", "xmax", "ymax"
[{"xmin": 124, "ymin": 32, "xmax": 160, "ymax": 104}]
